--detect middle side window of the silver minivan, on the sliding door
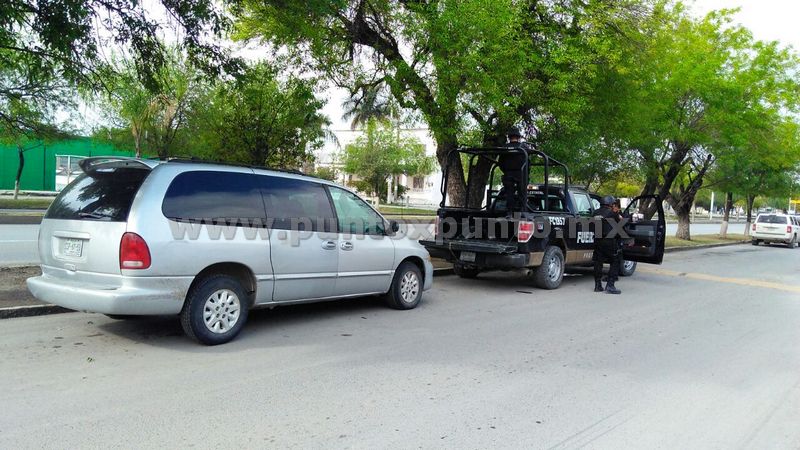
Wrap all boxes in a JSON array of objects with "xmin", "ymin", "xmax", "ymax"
[{"xmin": 258, "ymin": 175, "xmax": 336, "ymax": 232}]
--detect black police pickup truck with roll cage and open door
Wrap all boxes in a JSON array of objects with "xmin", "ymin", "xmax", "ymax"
[{"xmin": 420, "ymin": 144, "xmax": 666, "ymax": 289}]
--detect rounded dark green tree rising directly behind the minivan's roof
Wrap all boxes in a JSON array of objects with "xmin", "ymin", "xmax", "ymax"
[{"xmin": 190, "ymin": 62, "xmax": 330, "ymax": 168}]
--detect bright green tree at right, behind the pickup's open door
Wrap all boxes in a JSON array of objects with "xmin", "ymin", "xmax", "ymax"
[{"xmin": 608, "ymin": 4, "xmax": 797, "ymax": 239}]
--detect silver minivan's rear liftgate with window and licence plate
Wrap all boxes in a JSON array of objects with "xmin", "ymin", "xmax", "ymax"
[{"xmin": 39, "ymin": 158, "xmax": 151, "ymax": 281}]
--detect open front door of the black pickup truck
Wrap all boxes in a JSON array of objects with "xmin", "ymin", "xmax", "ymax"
[{"xmin": 622, "ymin": 195, "xmax": 667, "ymax": 264}]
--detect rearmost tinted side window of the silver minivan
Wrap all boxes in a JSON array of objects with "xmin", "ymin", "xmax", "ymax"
[{"xmin": 161, "ymin": 170, "xmax": 266, "ymax": 226}]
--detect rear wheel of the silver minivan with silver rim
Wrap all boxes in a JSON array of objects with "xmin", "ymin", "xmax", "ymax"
[{"xmin": 180, "ymin": 275, "xmax": 248, "ymax": 345}]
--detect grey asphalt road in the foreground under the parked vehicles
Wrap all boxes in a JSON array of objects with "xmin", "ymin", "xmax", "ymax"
[{"xmin": 0, "ymin": 245, "xmax": 800, "ymax": 449}]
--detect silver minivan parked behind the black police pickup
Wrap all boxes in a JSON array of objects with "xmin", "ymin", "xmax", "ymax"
[{"xmin": 28, "ymin": 158, "xmax": 433, "ymax": 345}]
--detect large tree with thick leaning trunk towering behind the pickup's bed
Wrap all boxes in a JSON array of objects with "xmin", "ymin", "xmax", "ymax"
[{"xmin": 234, "ymin": 0, "xmax": 643, "ymax": 203}]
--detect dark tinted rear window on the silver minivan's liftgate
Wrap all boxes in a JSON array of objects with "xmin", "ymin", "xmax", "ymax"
[{"xmin": 45, "ymin": 168, "xmax": 150, "ymax": 222}]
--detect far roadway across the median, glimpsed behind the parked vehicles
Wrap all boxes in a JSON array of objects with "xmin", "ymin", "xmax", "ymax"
[{"xmin": 0, "ymin": 223, "xmax": 744, "ymax": 266}]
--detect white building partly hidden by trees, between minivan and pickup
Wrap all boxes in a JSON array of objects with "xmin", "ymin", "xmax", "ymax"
[{"xmin": 315, "ymin": 128, "xmax": 442, "ymax": 206}]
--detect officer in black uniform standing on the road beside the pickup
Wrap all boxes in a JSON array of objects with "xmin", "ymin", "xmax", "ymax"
[{"xmin": 592, "ymin": 195, "xmax": 622, "ymax": 294}]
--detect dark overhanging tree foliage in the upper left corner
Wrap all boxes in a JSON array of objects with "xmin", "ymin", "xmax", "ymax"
[{"xmin": 0, "ymin": 0, "xmax": 238, "ymax": 96}]
